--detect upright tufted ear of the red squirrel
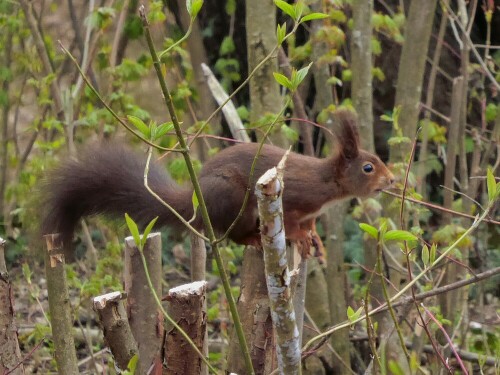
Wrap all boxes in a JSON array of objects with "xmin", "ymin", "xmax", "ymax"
[{"xmin": 335, "ymin": 109, "xmax": 359, "ymax": 159}]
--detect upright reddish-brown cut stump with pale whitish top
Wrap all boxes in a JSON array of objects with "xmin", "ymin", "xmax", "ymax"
[{"xmin": 163, "ymin": 281, "xmax": 207, "ymax": 375}]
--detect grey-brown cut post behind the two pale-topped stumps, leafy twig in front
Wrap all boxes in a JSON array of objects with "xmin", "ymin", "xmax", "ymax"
[{"xmin": 124, "ymin": 233, "xmax": 163, "ymax": 374}]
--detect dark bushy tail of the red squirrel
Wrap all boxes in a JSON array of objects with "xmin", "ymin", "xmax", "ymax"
[{"xmin": 41, "ymin": 143, "xmax": 193, "ymax": 248}]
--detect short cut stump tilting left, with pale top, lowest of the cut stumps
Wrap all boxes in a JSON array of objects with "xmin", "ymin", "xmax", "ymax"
[{"xmin": 93, "ymin": 292, "xmax": 138, "ymax": 371}]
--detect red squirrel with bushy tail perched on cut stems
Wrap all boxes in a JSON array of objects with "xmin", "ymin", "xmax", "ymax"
[{"xmin": 42, "ymin": 111, "xmax": 394, "ymax": 256}]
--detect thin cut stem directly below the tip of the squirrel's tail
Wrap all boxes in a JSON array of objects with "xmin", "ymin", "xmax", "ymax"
[{"xmin": 44, "ymin": 234, "xmax": 78, "ymax": 374}]
